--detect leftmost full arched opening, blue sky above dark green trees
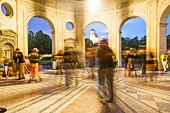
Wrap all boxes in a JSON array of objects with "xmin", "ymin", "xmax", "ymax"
[{"xmin": 28, "ymin": 17, "xmax": 52, "ymax": 54}]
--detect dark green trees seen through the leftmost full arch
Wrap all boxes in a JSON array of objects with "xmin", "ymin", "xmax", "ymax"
[{"xmin": 28, "ymin": 30, "xmax": 52, "ymax": 54}]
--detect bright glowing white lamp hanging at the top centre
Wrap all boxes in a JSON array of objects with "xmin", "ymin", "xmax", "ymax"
[{"xmin": 89, "ymin": 0, "xmax": 99, "ymax": 13}]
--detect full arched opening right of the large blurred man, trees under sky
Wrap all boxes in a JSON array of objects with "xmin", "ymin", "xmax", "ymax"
[{"xmin": 121, "ymin": 17, "xmax": 146, "ymax": 68}]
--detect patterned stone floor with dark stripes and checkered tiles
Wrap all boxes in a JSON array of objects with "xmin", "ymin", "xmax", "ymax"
[{"xmin": 0, "ymin": 69, "xmax": 170, "ymax": 113}]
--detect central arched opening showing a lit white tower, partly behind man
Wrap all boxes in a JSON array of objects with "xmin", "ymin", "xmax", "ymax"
[{"xmin": 85, "ymin": 22, "xmax": 108, "ymax": 67}]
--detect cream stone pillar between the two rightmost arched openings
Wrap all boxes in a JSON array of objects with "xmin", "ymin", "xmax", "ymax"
[{"xmin": 146, "ymin": 1, "xmax": 159, "ymax": 68}]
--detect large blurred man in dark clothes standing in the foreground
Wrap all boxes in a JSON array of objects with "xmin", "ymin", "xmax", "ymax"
[{"xmin": 97, "ymin": 39, "xmax": 114, "ymax": 103}]
